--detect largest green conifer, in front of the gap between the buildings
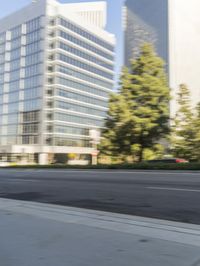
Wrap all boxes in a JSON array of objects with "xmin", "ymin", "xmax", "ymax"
[{"xmin": 100, "ymin": 44, "xmax": 170, "ymax": 161}]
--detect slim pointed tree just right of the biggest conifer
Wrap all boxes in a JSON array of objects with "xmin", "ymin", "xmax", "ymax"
[{"xmin": 171, "ymin": 84, "xmax": 195, "ymax": 159}]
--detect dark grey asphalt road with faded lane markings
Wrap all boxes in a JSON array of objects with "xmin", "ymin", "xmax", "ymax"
[{"xmin": 0, "ymin": 169, "xmax": 200, "ymax": 224}]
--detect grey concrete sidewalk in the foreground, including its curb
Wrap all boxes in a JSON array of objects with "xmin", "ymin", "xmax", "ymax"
[{"xmin": 0, "ymin": 199, "xmax": 200, "ymax": 266}]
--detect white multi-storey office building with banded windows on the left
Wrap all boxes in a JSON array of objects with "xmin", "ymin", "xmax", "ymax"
[{"xmin": 0, "ymin": 0, "xmax": 115, "ymax": 164}]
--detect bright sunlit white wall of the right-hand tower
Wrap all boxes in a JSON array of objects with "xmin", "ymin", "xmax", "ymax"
[{"xmin": 169, "ymin": 0, "xmax": 200, "ymax": 115}]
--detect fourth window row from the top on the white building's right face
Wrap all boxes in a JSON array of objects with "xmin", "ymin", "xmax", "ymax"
[{"xmin": 58, "ymin": 54, "xmax": 113, "ymax": 80}]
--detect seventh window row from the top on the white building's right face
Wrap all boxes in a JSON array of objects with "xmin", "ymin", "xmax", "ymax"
[{"xmin": 56, "ymin": 89, "xmax": 108, "ymax": 107}]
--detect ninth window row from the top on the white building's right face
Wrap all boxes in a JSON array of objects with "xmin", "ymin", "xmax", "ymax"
[{"xmin": 54, "ymin": 112, "xmax": 104, "ymax": 127}]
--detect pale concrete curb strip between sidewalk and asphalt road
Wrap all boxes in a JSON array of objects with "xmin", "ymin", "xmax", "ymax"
[{"xmin": 0, "ymin": 198, "xmax": 200, "ymax": 247}]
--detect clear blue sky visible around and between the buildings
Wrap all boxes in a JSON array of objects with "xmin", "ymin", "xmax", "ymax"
[{"xmin": 0, "ymin": 0, "xmax": 124, "ymax": 89}]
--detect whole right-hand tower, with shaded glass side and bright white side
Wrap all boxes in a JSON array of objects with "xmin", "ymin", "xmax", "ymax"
[{"xmin": 125, "ymin": 0, "xmax": 200, "ymax": 116}]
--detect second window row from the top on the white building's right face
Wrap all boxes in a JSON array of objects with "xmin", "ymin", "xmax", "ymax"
[{"xmin": 59, "ymin": 30, "xmax": 114, "ymax": 61}]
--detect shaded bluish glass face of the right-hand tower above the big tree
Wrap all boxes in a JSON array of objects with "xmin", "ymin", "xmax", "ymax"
[{"xmin": 125, "ymin": 0, "xmax": 168, "ymax": 65}]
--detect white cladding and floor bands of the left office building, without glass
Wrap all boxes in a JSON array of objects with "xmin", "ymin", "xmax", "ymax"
[{"xmin": 0, "ymin": 0, "xmax": 115, "ymax": 159}]
